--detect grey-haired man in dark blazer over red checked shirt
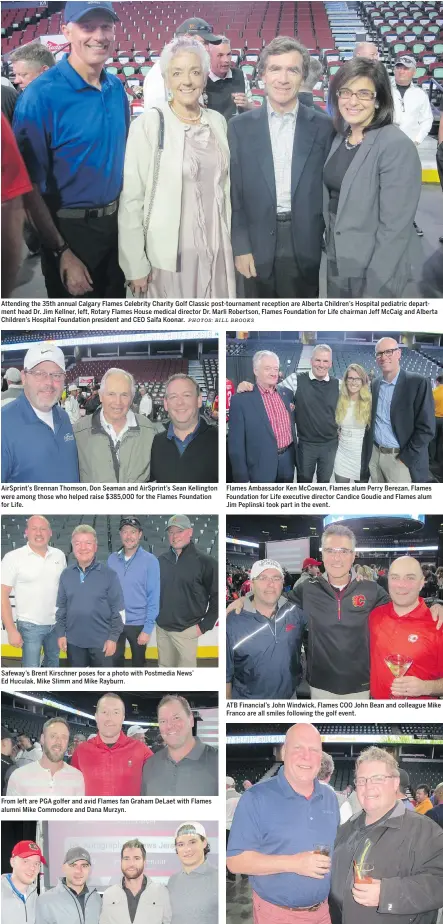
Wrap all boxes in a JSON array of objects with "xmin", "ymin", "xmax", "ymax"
[{"xmin": 228, "ymin": 350, "xmax": 295, "ymax": 484}]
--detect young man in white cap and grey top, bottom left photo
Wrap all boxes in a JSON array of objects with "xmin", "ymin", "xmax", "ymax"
[{"xmin": 168, "ymin": 821, "xmax": 218, "ymax": 924}]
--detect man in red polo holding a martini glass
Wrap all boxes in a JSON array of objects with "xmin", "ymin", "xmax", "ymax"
[{"xmin": 369, "ymin": 555, "xmax": 443, "ymax": 699}]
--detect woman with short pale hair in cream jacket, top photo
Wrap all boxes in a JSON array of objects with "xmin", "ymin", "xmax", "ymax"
[{"xmin": 119, "ymin": 36, "xmax": 236, "ymax": 299}]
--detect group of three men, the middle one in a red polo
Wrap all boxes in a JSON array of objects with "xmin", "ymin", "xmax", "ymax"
[{"xmin": 1, "ymin": 693, "xmax": 218, "ymax": 799}]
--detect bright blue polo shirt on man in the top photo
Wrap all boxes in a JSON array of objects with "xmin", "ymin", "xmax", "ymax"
[{"xmin": 13, "ymin": 55, "xmax": 130, "ymax": 209}]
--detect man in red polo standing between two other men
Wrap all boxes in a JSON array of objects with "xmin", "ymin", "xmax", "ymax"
[{"xmin": 71, "ymin": 693, "xmax": 153, "ymax": 796}]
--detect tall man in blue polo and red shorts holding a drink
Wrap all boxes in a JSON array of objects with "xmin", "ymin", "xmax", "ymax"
[{"xmin": 226, "ymin": 723, "xmax": 340, "ymax": 924}]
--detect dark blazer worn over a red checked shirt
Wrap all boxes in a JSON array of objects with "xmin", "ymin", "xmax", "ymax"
[{"xmin": 228, "ymin": 385, "xmax": 295, "ymax": 484}]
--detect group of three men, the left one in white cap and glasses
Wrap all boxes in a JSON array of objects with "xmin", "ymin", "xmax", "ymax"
[{"xmin": 1, "ymin": 343, "xmax": 218, "ymax": 484}]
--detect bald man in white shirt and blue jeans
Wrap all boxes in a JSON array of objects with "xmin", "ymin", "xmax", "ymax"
[{"xmin": 2, "ymin": 516, "xmax": 66, "ymax": 667}]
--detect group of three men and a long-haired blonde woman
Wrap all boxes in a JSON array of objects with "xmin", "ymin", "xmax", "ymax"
[{"xmin": 228, "ymin": 337, "xmax": 443, "ymax": 484}]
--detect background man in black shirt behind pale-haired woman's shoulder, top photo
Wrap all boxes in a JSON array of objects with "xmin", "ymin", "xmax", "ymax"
[{"xmin": 205, "ymin": 35, "xmax": 254, "ymax": 122}]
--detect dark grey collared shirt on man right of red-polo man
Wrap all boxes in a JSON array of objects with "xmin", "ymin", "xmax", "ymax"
[{"xmin": 142, "ymin": 738, "xmax": 218, "ymax": 796}]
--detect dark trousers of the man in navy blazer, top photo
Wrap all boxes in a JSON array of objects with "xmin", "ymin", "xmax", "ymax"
[{"xmin": 245, "ymin": 219, "xmax": 318, "ymax": 299}]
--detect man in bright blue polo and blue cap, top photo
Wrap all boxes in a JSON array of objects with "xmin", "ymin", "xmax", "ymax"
[{"xmin": 13, "ymin": 2, "xmax": 130, "ymax": 298}]
